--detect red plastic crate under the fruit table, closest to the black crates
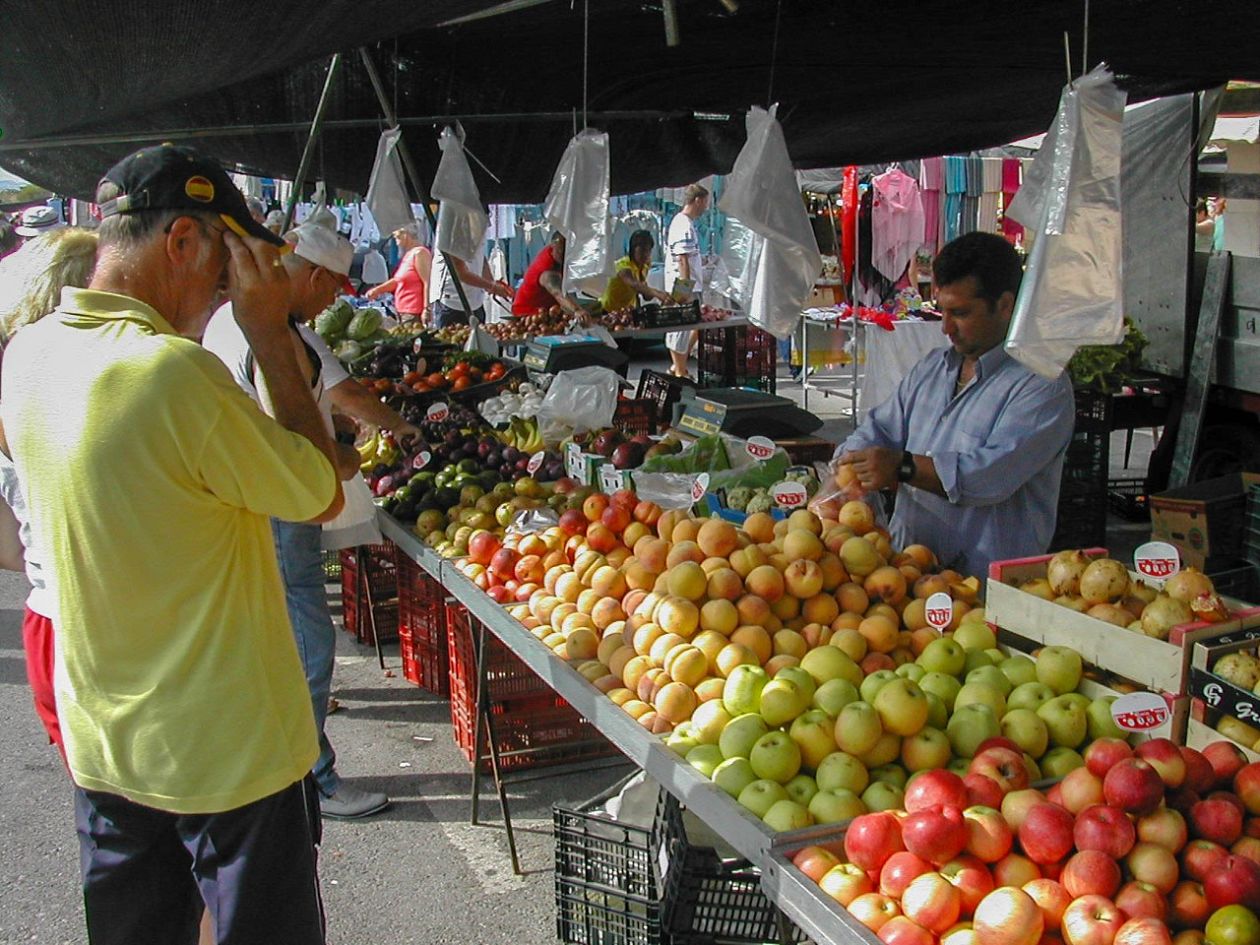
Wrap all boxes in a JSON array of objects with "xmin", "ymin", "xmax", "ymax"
[{"xmin": 446, "ymin": 601, "xmax": 616, "ymax": 771}]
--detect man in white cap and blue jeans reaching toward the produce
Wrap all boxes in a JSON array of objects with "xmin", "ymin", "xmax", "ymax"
[{"xmin": 202, "ymin": 223, "xmax": 420, "ymax": 819}]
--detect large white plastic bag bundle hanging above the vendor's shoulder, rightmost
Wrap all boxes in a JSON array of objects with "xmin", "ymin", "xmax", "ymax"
[{"xmin": 1005, "ymin": 66, "xmax": 1125, "ymax": 378}]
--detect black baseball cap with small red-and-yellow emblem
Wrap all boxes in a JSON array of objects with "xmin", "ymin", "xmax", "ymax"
[{"xmin": 98, "ymin": 145, "xmax": 285, "ymax": 247}]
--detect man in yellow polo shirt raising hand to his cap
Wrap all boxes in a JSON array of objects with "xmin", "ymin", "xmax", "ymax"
[{"xmin": 0, "ymin": 146, "xmax": 341, "ymax": 945}]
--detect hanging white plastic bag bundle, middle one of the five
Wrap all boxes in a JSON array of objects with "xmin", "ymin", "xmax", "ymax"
[{"xmin": 543, "ymin": 129, "xmax": 612, "ymax": 295}]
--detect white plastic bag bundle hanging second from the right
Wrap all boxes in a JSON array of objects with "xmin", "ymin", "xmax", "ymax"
[{"xmin": 721, "ymin": 106, "xmax": 823, "ymax": 338}]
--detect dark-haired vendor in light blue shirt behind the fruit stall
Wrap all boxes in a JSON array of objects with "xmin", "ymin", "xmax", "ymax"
[{"xmin": 834, "ymin": 233, "xmax": 1075, "ymax": 580}]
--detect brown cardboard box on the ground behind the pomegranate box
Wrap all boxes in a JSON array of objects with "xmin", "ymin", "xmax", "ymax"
[{"xmin": 1150, "ymin": 473, "xmax": 1260, "ymax": 571}]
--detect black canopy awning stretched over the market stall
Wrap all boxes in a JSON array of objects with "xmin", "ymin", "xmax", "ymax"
[{"xmin": 0, "ymin": 0, "xmax": 1260, "ymax": 202}]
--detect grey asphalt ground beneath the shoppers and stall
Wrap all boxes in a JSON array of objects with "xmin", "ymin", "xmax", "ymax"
[{"xmin": 0, "ymin": 572, "xmax": 627, "ymax": 945}]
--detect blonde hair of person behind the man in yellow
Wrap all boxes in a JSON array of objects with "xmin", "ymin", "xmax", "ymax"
[{"xmin": 0, "ymin": 227, "xmax": 97, "ymax": 345}]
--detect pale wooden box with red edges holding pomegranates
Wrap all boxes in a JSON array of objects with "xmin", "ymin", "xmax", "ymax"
[{"xmin": 984, "ymin": 548, "xmax": 1260, "ymax": 696}]
